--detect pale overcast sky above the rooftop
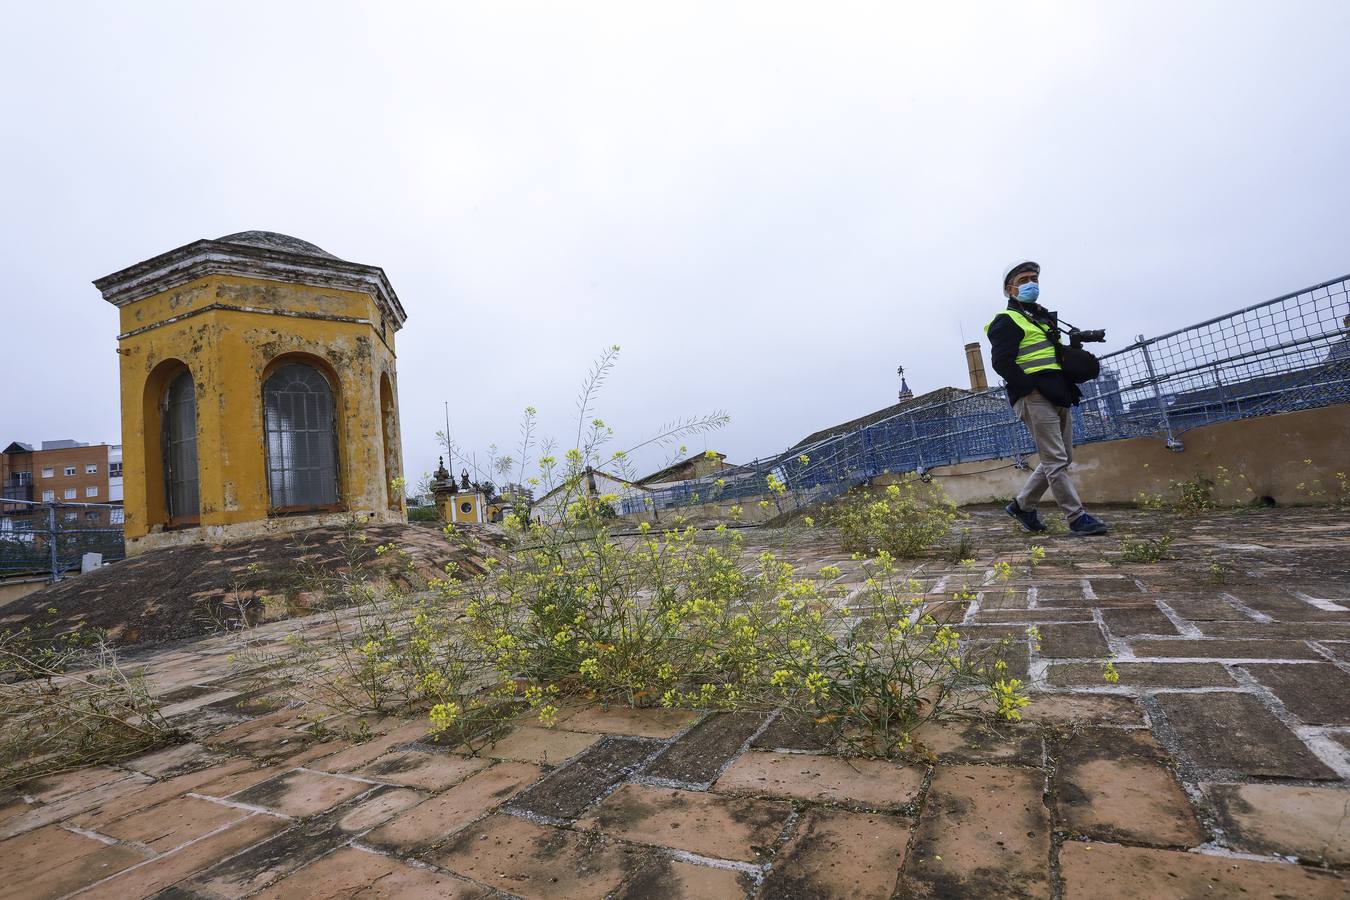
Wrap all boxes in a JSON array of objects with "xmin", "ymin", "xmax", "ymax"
[{"xmin": 0, "ymin": 0, "xmax": 1350, "ymax": 485}]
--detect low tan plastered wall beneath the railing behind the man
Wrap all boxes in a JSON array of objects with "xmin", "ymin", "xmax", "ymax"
[{"xmin": 873, "ymin": 403, "xmax": 1350, "ymax": 506}]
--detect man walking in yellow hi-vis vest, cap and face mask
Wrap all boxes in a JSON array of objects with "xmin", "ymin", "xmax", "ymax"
[{"xmin": 984, "ymin": 260, "xmax": 1107, "ymax": 536}]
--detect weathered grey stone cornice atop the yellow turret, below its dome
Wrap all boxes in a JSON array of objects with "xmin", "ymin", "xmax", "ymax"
[{"xmin": 93, "ymin": 240, "xmax": 408, "ymax": 329}]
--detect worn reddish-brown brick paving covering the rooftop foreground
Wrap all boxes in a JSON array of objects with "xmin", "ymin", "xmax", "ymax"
[{"xmin": 0, "ymin": 510, "xmax": 1350, "ymax": 900}]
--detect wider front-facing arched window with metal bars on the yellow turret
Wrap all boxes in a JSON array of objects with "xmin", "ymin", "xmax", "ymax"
[{"xmin": 262, "ymin": 363, "xmax": 338, "ymax": 511}]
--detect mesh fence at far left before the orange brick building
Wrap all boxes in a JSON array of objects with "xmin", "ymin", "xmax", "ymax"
[{"xmin": 0, "ymin": 498, "xmax": 127, "ymax": 580}]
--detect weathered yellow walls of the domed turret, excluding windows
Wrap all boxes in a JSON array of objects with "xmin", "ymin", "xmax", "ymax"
[{"xmin": 119, "ymin": 275, "xmax": 405, "ymax": 549}]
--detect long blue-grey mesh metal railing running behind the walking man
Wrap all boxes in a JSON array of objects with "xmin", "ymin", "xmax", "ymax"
[{"xmin": 620, "ymin": 275, "xmax": 1350, "ymax": 515}]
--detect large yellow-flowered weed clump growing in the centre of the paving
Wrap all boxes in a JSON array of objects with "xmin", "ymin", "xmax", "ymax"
[{"xmin": 432, "ymin": 348, "xmax": 1026, "ymax": 753}]
